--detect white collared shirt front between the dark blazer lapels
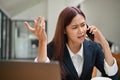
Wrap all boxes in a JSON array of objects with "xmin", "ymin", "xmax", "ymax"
[{"xmin": 66, "ymin": 44, "xmax": 84, "ymax": 76}]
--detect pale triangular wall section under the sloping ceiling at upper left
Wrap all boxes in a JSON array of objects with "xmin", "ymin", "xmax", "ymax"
[{"xmin": 12, "ymin": 0, "xmax": 47, "ymax": 20}]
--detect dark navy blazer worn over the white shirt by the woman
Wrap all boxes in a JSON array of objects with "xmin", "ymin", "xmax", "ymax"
[{"xmin": 47, "ymin": 40, "xmax": 118, "ymax": 80}]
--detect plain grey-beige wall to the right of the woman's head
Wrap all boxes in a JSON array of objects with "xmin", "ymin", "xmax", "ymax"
[{"xmin": 81, "ymin": 0, "xmax": 120, "ymax": 44}]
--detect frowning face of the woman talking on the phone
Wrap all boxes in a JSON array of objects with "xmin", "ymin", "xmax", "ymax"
[{"xmin": 65, "ymin": 14, "xmax": 87, "ymax": 44}]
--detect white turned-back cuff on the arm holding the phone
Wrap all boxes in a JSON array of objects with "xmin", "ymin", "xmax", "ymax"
[{"xmin": 104, "ymin": 58, "xmax": 118, "ymax": 76}]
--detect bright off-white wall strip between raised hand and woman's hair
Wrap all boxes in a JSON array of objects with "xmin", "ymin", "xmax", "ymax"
[{"xmin": 47, "ymin": 0, "xmax": 65, "ymax": 42}]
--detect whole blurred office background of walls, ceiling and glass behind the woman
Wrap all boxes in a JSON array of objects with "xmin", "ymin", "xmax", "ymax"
[{"xmin": 0, "ymin": 0, "xmax": 120, "ymax": 60}]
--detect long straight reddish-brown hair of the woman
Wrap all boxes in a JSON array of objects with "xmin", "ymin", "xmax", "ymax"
[{"xmin": 51, "ymin": 7, "xmax": 86, "ymax": 79}]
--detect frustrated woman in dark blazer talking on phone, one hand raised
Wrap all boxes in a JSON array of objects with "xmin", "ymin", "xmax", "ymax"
[{"xmin": 25, "ymin": 7, "xmax": 118, "ymax": 80}]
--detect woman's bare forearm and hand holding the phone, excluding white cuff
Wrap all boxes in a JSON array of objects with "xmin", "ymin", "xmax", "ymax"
[{"xmin": 90, "ymin": 26, "xmax": 114, "ymax": 66}]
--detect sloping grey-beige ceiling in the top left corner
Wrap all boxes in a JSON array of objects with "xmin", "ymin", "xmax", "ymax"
[{"xmin": 0, "ymin": 0, "xmax": 42, "ymax": 17}]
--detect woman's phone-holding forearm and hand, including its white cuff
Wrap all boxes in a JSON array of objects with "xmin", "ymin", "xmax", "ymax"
[{"xmin": 90, "ymin": 26, "xmax": 118, "ymax": 76}]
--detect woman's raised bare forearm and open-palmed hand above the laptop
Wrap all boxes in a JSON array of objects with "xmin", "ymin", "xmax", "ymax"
[{"xmin": 25, "ymin": 17, "xmax": 47, "ymax": 62}]
